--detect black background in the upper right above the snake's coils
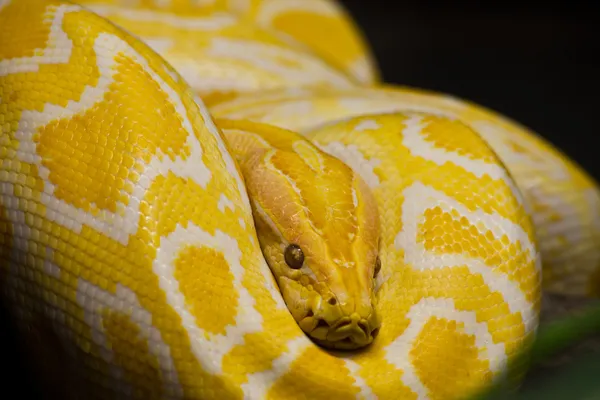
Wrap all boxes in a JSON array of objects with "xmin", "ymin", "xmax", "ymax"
[{"xmin": 340, "ymin": 0, "xmax": 600, "ymax": 179}]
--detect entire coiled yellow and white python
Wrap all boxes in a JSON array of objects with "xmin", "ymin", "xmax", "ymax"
[{"xmin": 0, "ymin": 0, "xmax": 600, "ymax": 400}]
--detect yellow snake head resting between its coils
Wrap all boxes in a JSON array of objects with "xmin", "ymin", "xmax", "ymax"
[{"xmin": 240, "ymin": 140, "xmax": 381, "ymax": 349}]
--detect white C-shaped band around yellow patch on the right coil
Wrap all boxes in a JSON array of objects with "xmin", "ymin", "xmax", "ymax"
[{"xmin": 394, "ymin": 183, "xmax": 539, "ymax": 332}]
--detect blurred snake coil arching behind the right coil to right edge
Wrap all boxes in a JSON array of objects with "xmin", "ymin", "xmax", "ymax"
[{"xmin": 211, "ymin": 86, "xmax": 600, "ymax": 297}]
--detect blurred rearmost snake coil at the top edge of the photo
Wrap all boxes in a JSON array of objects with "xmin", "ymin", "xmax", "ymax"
[{"xmin": 78, "ymin": 0, "xmax": 379, "ymax": 91}]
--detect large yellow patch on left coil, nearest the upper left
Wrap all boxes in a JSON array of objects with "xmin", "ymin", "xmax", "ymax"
[{"xmin": 36, "ymin": 52, "xmax": 189, "ymax": 215}]
